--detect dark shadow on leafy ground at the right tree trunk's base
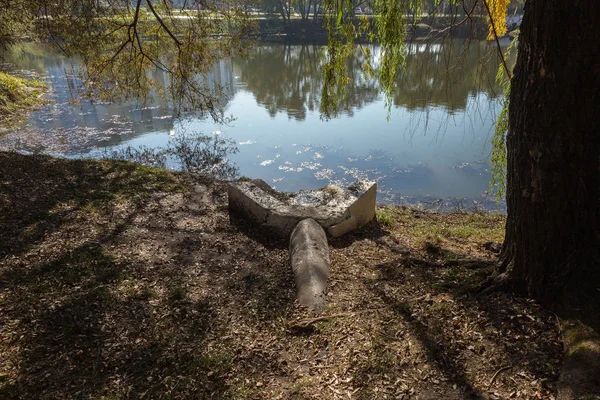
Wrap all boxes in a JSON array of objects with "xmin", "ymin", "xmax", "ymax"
[{"xmin": 370, "ymin": 245, "xmax": 561, "ymax": 397}]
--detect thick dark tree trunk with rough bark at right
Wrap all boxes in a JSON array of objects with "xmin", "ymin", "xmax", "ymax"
[{"xmin": 501, "ymin": 0, "xmax": 600, "ymax": 307}]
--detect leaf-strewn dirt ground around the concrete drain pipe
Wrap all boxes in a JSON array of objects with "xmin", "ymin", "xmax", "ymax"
[{"xmin": 0, "ymin": 153, "xmax": 562, "ymax": 399}]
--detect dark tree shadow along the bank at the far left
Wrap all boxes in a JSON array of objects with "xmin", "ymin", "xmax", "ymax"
[{"xmin": 0, "ymin": 152, "xmax": 177, "ymax": 258}]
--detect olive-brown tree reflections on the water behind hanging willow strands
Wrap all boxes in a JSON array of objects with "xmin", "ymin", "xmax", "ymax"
[{"xmin": 233, "ymin": 40, "xmax": 501, "ymax": 121}]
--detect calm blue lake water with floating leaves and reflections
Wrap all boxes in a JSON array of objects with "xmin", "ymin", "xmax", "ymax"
[{"xmin": 0, "ymin": 40, "xmax": 504, "ymax": 211}]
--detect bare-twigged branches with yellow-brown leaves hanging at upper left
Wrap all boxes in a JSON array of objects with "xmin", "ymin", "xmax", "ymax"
[{"xmin": 0, "ymin": 0, "xmax": 255, "ymax": 120}]
